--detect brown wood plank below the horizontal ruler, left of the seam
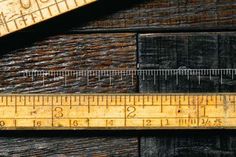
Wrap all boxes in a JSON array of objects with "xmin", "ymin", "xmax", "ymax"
[{"xmin": 0, "ymin": 136, "xmax": 138, "ymax": 157}]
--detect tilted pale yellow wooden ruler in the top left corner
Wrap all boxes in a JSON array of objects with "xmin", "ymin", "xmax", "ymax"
[{"xmin": 0, "ymin": 0, "xmax": 96, "ymax": 37}]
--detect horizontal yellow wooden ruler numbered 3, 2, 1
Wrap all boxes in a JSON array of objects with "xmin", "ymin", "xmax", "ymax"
[{"xmin": 0, "ymin": 93, "xmax": 236, "ymax": 129}]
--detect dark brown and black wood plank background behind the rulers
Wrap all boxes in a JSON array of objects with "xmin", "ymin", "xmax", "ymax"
[{"xmin": 0, "ymin": 0, "xmax": 236, "ymax": 157}]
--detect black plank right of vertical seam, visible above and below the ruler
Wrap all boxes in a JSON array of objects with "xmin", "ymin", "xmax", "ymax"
[{"xmin": 138, "ymin": 32, "xmax": 236, "ymax": 157}]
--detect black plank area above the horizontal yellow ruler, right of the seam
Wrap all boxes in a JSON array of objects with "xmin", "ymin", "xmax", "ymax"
[{"xmin": 139, "ymin": 32, "xmax": 236, "ymax": 92}]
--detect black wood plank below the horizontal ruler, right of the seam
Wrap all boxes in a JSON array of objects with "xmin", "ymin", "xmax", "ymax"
[{"xmin": 140, "ymin": 130, "xmax": 236, "ymax": 157}]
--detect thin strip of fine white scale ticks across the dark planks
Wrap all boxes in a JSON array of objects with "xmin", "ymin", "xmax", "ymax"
[{"xmin": 18, "ymin": 69, "xmax": 236, "ymax": 85}]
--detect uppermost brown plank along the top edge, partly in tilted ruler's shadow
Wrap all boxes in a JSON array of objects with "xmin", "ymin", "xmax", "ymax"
[{"xmin": 5, "ymin": 0, "xmax": 236, "ymax": 36}]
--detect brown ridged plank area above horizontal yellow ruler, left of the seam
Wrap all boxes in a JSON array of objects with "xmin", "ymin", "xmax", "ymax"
[{"xmin": 0, "ymin": 33, "xmax": 136, "ymax": 93}]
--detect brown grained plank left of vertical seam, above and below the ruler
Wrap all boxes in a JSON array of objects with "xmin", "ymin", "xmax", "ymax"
[{"xmin": 0, "ymin": 33, "xmax": 138, "ymax": 156}]
